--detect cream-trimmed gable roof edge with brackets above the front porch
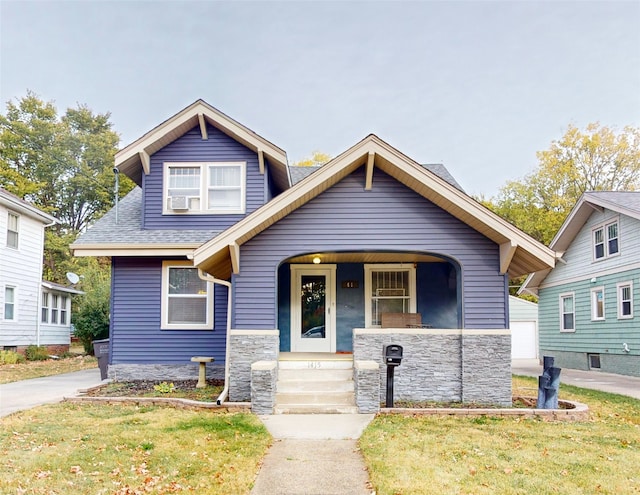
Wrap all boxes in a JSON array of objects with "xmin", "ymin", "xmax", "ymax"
[{"xmin": 194, "ymin": 134, "xmax": 555, "ymax": 278}]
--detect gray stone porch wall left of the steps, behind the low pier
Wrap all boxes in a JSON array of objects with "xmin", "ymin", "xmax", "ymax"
[{"xmin": 229, "ymin": 330, "xmax": 280, "ymax": 402}]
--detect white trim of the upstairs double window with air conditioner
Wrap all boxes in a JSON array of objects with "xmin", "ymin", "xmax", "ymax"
[{"xmin": 162, "ymin": 162, "xmax": 247, "ymax": 215}]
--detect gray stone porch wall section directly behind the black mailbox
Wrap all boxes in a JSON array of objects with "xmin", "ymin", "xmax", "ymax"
[{"xmin": 353, "ymin": 329, "xmax": 462, "ymax": 402}]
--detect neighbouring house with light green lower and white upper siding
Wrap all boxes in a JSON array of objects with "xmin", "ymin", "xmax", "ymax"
[{"xmin": 521, "ymin": 191, "xmax": 640, "ymax": 376}]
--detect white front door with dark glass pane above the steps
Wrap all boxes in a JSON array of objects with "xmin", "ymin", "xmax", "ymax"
[{"xmin": 291, "ymin": 265, "xmax": 336, "ymax": 352}]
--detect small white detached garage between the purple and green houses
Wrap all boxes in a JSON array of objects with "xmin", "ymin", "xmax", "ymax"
[{"xmin": 509, "ymin": 296, "xmax": 538, "ymax": 359}]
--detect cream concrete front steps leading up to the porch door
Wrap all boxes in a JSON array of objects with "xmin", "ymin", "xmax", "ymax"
[{"xmin": 273, "ymin": 352, "xmax": 358, "ymax": 414}]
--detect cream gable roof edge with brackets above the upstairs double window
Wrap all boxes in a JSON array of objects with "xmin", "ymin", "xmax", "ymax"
[{"xmin": 115, "ymin": 100, "xmax": 289, "ymax": 190}]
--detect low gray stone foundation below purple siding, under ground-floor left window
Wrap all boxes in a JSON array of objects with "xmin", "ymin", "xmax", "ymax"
[{"xmin": 107, "ymin": 362, "xmax": 224, "ymax": 382}]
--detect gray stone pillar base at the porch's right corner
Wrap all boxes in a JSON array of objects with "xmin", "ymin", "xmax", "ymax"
[{"xmin": 462, "ymin": 332, "xmax": 512, "ymax": 406}]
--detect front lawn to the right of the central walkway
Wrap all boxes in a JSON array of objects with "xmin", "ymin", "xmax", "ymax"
[{"xmin": 360, "ymin": 377, "xmax": 640, "ymax": 495}]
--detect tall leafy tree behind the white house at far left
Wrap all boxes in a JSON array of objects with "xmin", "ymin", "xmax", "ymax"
[{"xmin": 0, "ymin": 92, "xmax": 133, "ymax": 239}]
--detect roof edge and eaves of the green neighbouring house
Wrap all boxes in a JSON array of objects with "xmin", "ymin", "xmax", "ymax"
[{"xmin": 518, "ymin": 191, "xmax": 640, "ymax": 295}]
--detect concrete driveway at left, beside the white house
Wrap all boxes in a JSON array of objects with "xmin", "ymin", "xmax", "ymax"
[{"xmin": 0, "ymin": 368, "xmax": 102, "ymax": 417}]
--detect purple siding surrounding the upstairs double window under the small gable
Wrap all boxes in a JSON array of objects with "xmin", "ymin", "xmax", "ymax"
[{"xmin": 142, "ymin": 126, "xmax": 271, "ymax": 231}]
